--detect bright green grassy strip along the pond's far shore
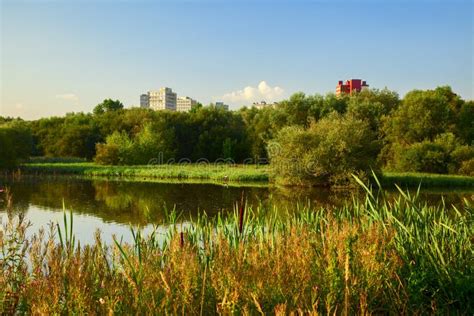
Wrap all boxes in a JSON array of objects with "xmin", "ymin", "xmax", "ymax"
[{"xmin": 19, "ymin": 162, "xmax": 474, "ymax": 188}]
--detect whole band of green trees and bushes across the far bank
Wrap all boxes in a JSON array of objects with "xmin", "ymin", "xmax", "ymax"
[{"xmin": 0, "ymin": 87, "xmax": 474, "ymax": 184}]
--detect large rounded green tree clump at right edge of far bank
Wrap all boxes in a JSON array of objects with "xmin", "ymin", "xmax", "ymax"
[{"xmin": 380, "ymin": 87, "xmax": 474, "ymax": 174}]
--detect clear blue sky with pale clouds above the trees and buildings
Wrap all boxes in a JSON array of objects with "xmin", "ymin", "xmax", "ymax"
[{"xmin": 0, "ymin": 0, "xmax": 474, "ymax": 119}]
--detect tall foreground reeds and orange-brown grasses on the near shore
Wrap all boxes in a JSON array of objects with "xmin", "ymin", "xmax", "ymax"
[{"xmin": 0, "ymin": 183, "xmax": 474, "ymax": 315}]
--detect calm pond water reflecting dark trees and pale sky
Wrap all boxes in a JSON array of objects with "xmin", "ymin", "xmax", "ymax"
[{"xmin": 0, "ymin": 178, "xmax": 474, "ymax": 243}]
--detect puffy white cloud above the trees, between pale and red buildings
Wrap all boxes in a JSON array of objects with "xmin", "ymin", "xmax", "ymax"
[{"xmin": 222, "ymin": 81, "xmax": 285, "ymax": 103}]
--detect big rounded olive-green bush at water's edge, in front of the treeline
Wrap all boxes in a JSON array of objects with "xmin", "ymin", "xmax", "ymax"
[{"xmin": 269, "ymin": 113, "xmax": 380, "ymax": 186}]
